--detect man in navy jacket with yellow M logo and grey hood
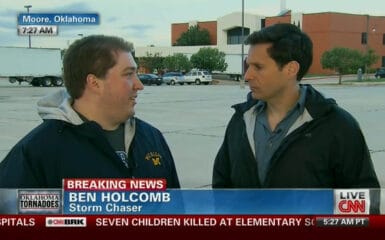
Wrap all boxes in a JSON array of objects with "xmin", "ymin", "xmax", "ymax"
[{"xmin": 0, "ymin": 35, "xmax": 180, "ymax": 188}]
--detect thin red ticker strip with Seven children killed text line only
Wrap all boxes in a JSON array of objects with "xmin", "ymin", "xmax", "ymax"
[{"xmin": 0, "ymin": 215, "xmax": 385, "ymax": 229}]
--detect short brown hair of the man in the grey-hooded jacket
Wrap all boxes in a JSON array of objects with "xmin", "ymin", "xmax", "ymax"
[{"xmin": 63, "ymin": 35, "xmax": 134, "ymax": 99}]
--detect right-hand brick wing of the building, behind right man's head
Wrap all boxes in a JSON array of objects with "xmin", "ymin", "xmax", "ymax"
[{"xmin": 265, "ymin": 11, "xmax": 385, "ymax": 74}]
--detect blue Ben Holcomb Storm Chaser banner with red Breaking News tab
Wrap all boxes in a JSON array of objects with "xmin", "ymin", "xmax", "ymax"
[{"xmin": 0, "ymin": 179, "xmax": 385, "ymax": 216}]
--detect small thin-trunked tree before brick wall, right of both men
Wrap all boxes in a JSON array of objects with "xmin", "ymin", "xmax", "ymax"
[{"xmin": 321, "ymin": 47, "xmax": 364, "ymax": 84}]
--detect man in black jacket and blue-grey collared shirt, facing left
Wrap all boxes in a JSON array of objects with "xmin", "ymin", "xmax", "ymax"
[{"xmin": 212, "ymin": 24, "xmax": 379, "ymax": 188}]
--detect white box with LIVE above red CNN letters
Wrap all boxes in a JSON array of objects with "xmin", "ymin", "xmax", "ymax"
[{"xmin": 334, "ymin": 189, "xmax": 370, "ymax": 214}]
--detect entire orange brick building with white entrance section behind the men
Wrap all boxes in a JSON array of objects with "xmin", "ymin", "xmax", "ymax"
[{"xmin": 171, "ymin": 11, "xmax": 385, "ymax": 74}]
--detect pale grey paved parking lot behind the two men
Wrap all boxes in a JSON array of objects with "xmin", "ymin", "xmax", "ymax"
[{"xmin": 0, "ymin": 79, "xmax": 385, "ymax": 188}]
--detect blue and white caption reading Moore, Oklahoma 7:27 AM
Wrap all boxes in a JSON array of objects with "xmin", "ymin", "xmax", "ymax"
[{"xmin": 17, "ymin": 13, "xmax": 100, "ymax": 36}]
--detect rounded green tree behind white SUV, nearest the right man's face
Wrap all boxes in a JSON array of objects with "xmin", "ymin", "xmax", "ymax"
[{"xmin": 190, "ymin": 47, "xmax": 227, "ymax": 72}]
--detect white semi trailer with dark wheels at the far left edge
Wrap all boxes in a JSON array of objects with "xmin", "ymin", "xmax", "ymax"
[{"xmin": 0, "ymin": 47, "xmax": 63, "ymax": 87}]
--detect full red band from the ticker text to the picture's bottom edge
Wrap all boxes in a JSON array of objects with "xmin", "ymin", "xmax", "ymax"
[{"xmin": 0, "ymin": 215, "xmax": 385, "ymax": 240}]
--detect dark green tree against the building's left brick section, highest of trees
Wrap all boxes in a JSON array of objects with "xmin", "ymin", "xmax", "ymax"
[{"xmin": 175, "ymin": 25, "xmax": 210, "ymax": 46}]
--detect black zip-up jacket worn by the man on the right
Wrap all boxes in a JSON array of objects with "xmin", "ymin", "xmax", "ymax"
[{"xmin": 212, "ymin": 85, "xmax": 379, "ymax": 188}]
